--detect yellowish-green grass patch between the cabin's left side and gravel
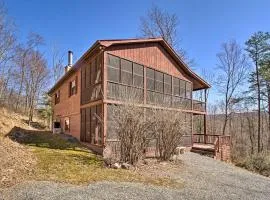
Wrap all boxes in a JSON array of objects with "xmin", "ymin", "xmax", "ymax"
[{"xmin": 25, "ymin": 133, "xmax": 183, "ymax": 188}]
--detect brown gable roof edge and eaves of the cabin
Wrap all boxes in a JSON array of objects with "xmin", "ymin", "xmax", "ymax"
[{"xmin": 48, "ymin": 37, "xmax": 211, "ymax": 94}]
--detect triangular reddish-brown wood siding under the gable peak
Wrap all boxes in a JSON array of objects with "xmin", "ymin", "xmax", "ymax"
[{"xmin": 106, "ymin": 43, "xmax": 192, "ymax": 82}]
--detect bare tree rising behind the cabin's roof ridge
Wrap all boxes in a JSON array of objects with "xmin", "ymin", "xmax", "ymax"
[{"xmin": 139, "ymin": 5, "xmax": 193, "ymax": 64}]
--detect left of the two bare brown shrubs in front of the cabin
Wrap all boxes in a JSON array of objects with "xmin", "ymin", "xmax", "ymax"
[{"xmin": 108, "ymin": 105, "xmax": 152, "ymax": 164}]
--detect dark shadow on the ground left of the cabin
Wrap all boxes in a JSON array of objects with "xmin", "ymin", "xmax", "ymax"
[{"xmin": 6, "ymin": 126, "xmax": 87, "ymax": 151}]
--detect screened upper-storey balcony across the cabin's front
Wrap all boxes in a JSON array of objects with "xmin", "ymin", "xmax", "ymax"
[{"xmin": 105, "ymin": 54, "xmax": 208, "ymax": 114}]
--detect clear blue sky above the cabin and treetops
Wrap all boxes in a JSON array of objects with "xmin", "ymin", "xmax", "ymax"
[{"xmin": 4, "ymin": 0, "xmax": 270, "ymax": 102}]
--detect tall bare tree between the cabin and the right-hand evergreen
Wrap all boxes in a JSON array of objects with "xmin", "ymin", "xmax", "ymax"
[{"xmin": 217, "ymin": 41, "xmax": 249, "ymax": 135}]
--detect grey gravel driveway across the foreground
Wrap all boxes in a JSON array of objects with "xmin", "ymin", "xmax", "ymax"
[{"xmin": 0, "ymin": 153, "xmax": 270, "ymax": 200}]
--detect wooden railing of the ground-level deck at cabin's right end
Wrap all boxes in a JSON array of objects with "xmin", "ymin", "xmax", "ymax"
[{"xmin": 193, "ymin": 134, "xmax": 231, "ymax": 151}]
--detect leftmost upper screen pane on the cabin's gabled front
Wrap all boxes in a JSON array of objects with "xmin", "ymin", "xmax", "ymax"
[{"xmin": 108, "ymin": 55, "xmax": 120, "ymax": 83}]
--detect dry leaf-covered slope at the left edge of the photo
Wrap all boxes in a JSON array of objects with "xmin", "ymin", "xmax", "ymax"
[{"xmin": 0, "ymin": 108, "xmax": 36, "ymax": 188}]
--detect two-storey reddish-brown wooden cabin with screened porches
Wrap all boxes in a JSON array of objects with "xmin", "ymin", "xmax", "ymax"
[{"xmin": 49, "ymin": 38, "xmax": 230, "ymax": 161}]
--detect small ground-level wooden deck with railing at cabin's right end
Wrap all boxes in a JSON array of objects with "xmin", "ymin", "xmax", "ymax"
[{"xmin": 191, "ymin": 134, "xmax": 231, "ymax": 161}]
